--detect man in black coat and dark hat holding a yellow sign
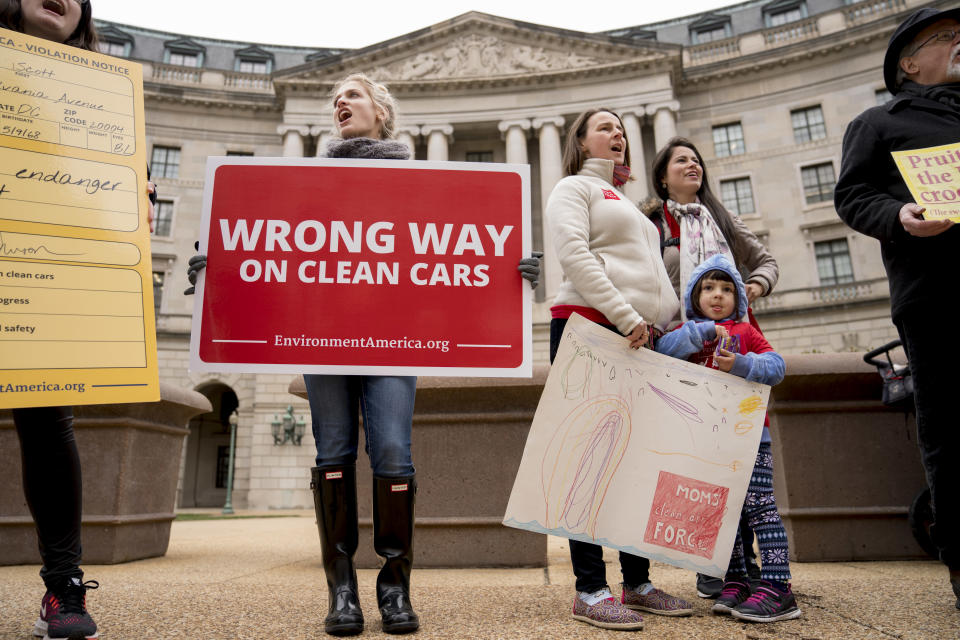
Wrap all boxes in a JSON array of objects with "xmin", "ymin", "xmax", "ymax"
[{"xmin": 834, "ymin": 8, "xmax": 960, "ymax": 609}]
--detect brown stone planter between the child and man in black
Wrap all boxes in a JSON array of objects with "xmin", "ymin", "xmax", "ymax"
[{"xmin": 769, "ymin": 353, "xmax": 926, "ymax": 562}]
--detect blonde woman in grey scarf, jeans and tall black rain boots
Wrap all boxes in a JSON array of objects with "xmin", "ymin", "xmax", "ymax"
[{"xmin": 187, "ymin": 73, "xmax": 539, "ymax": 635}]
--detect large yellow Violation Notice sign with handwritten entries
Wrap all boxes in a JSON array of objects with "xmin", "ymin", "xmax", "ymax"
[{"xmin": 0, "ymin": 29, "xmax": 160, "ymax": 408}]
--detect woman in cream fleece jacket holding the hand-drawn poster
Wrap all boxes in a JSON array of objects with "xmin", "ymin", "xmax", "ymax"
[{"xmin": 544, "ymin": 109, "xmax": 693, "ymax": 630}]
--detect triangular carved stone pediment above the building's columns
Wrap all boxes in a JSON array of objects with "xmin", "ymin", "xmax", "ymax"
[{"xmin": 274, "ymin": 12, "xmax": 680, "ymax": 89}]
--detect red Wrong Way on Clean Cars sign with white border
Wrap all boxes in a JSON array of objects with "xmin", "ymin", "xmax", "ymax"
[{"xmin": 191, "ymin": 158, "xmax": 532, "ymax": 376}]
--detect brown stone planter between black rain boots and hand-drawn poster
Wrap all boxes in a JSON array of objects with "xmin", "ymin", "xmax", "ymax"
[{"xmin": 289, "ymin": 366, "xmax": 549, "ymax": 568}]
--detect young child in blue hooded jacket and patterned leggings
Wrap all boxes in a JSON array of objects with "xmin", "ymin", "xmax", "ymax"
[{"xmin": 657, "ymin": 254, "xmax": 800, "ymax": 622}]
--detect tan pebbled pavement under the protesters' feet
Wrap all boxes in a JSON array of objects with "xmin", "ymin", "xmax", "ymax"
[{"xmin": 0, "ymin": 512, "xmax": 960, "ymax": 640}]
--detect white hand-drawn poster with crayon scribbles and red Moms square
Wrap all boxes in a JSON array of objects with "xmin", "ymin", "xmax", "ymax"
[{"xmin": 504, "ymin": 315, "xmax": 770, "ymax": 577}]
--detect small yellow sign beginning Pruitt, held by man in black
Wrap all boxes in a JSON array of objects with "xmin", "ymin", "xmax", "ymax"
[{"xmin": 892, "ymin": 144, "xmax": 960, "ymax": 222}]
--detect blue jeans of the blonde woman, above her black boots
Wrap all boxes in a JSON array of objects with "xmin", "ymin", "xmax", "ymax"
[{"xmin": 303, "ymin": 375, "xmax": 417, "ymax": 478}]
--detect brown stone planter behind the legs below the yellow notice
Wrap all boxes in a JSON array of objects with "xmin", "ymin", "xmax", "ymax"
[{"xmin": 0, "ymin": 382, "xmax": 211, "ymax": 565}]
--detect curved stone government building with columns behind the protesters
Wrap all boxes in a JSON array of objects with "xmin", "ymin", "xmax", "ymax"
[{"xmin": 105, "ymin": 0, "xmax": 928, "ymax": 509}]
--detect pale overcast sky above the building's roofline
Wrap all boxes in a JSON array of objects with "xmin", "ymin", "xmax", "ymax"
[{"xmin": 92, "ymin": 0, "xmax": 736, "ymax": 49}]
